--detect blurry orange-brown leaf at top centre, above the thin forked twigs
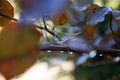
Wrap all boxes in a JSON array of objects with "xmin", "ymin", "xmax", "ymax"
[{"xmin": 51, "ymin": 11, "xmax": 68, "ymax": 25}]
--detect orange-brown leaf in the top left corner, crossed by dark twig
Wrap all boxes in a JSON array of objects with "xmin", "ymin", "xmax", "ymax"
[{"xmin": 0, "ymin": 0, "xmax": 14, "ymax": 27}]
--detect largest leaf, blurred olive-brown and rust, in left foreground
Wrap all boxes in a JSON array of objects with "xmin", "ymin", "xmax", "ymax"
[{"xmin": 0, "ymin": 21, "xmax": 41, "ymax": 80}]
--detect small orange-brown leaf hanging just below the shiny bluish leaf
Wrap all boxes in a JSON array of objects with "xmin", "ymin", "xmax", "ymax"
[{"xmin": 84, "ymin": 25, "xmax": 96, "ymax": 39}]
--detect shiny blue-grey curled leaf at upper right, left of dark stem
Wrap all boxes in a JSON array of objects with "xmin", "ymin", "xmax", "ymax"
[{"xmin": 87, "ymin": 7, "xmax": 112, "ymax": 25}]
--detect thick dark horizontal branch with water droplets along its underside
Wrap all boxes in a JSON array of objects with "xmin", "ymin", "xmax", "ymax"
[{"xmin": 39, "ymin": 45, "xmax": 120, "ymax": 56}]
